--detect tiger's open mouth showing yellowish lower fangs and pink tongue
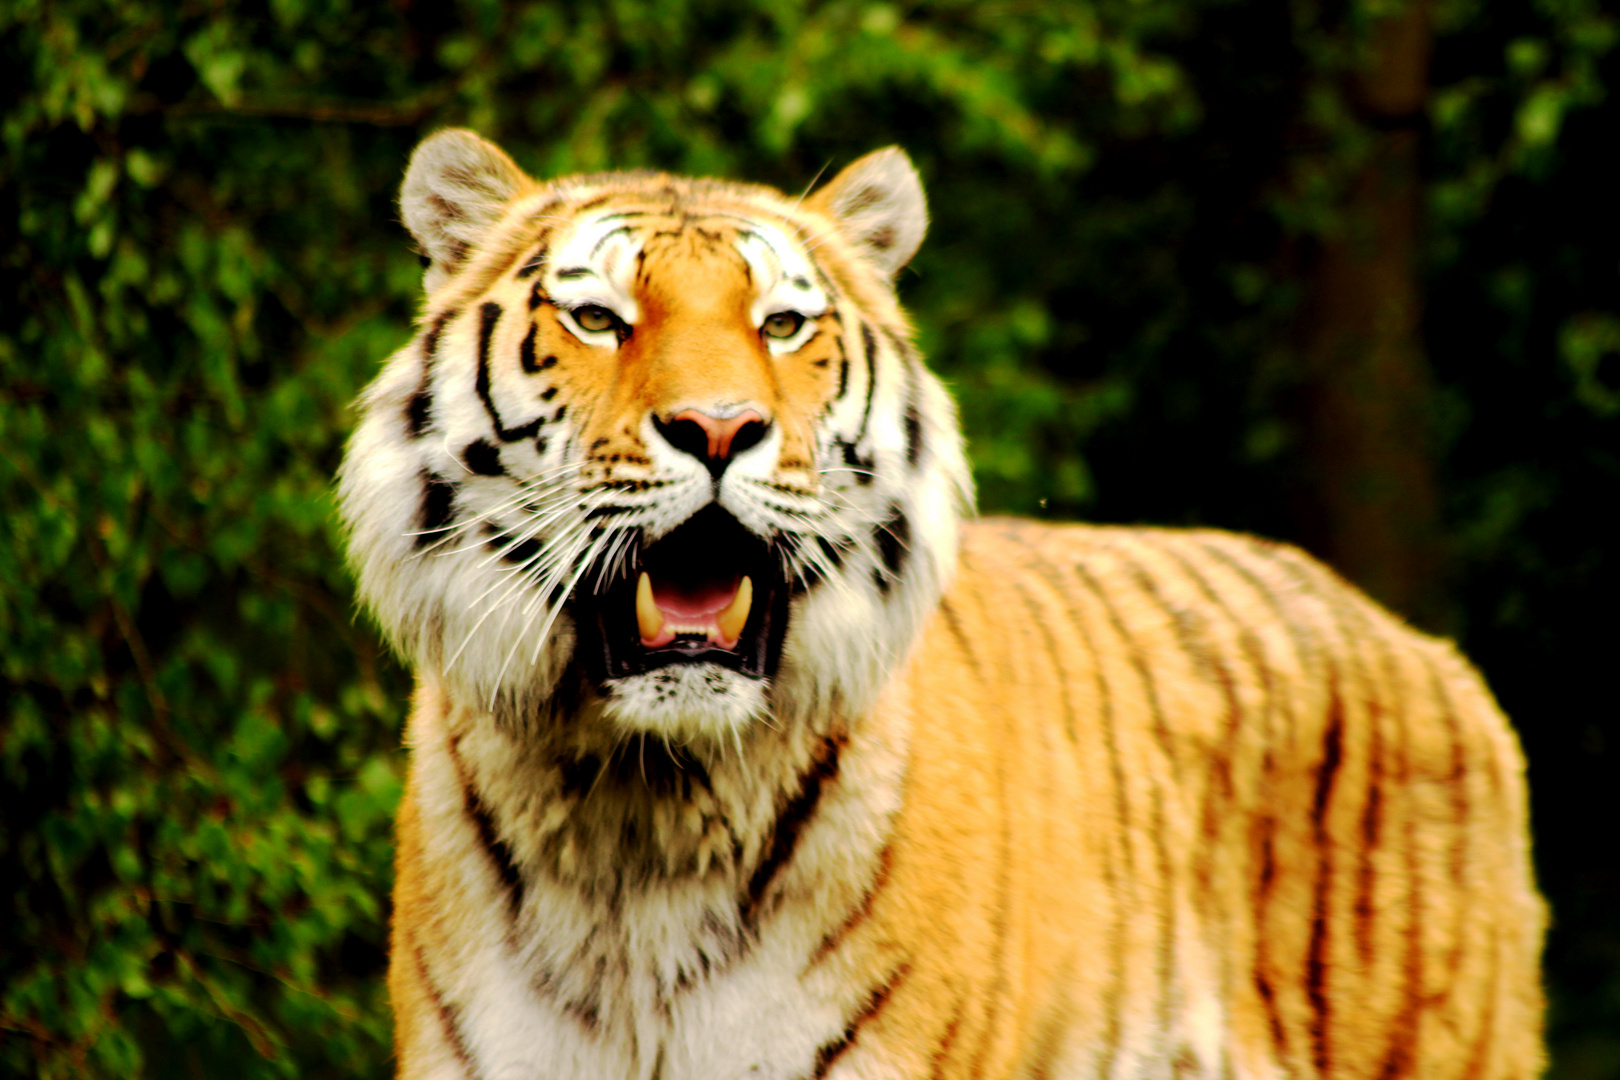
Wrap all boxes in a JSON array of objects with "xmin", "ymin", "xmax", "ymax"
[{"xmin": 570, "ymin": 504, "xmax": 789, "ymax": 682}]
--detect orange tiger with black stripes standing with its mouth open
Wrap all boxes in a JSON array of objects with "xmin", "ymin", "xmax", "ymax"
[{"xmin": 339, "ymin": 130, "xmax": 1545, "ymax": 1080}]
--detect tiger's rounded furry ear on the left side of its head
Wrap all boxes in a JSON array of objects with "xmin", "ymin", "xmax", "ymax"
[{"xmin": 400, "ymin": 128, "xmax": 528, "ymax": 293}]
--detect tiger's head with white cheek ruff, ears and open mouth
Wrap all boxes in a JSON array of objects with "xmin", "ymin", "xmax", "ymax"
[{"xmin": 340, "ymin": 130, "xmax": 970, "ymax": 742}]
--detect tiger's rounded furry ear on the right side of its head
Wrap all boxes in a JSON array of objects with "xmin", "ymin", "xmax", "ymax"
[{"xmin": 808, "ymin": 146, "xmax": 928, "ymax": 277}]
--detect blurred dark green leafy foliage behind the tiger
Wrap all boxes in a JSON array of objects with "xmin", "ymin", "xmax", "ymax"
[{"xmin": 0, "ymin": 0, "xmax": 1620, "ymax": 1080}]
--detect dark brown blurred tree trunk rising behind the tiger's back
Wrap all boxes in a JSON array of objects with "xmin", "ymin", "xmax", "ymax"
[{"xmin": 1299, "ymin": 3, "xmax": 1445, "ymax": 628}]
